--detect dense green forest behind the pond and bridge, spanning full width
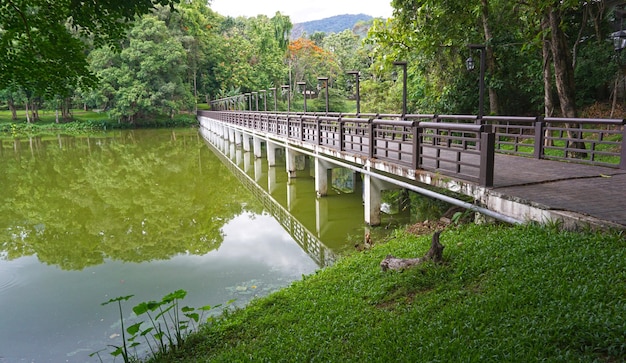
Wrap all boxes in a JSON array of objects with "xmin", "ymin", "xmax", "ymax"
[{"xmin": 0, "ymin": 0, "xmax": 626, "ymax": 123}]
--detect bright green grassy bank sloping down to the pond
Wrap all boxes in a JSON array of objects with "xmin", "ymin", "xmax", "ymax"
[{"xmin": 154, "ymin": 226, "xmax": 626, "ymax": 362}]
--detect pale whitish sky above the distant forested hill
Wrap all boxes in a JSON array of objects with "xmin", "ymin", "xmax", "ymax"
[{"xmin": 210, "ymin": 0, "xmax": 393, "ymax": 23}]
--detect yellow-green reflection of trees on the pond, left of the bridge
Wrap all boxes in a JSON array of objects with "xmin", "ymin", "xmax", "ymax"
[{"xmin": 0, "ymin": 130, "xmax": 261, "ymax": 270}]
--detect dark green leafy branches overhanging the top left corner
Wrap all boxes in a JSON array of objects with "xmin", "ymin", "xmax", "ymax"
[{"xmin": 0, "ymin": 0, "xmax": 178, "ymax": 107}]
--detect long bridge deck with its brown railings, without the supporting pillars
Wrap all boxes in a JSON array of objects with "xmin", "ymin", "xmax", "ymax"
[{"xmin": 197, "ymin": 110, "xmax": 626, "ymax": 228}]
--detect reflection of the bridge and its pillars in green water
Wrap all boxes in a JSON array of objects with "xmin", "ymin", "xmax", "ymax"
[{"xmin": 200, "ymin": 129, "xmax": 365, "ymax": 258}]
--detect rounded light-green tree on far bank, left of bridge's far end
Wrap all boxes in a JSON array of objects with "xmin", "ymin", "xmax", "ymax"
[{"xmin": 92, "ymin": 14, "xmax": 193, "ymax": 122}]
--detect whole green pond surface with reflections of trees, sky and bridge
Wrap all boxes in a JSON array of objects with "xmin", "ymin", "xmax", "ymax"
[{"xmin": 0, "ymin": 129, "xmax": 363, "ymax": 362}]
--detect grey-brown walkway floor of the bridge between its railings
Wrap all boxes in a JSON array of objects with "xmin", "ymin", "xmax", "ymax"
[{"xmin": 490, "ymin": 154, "xmax": 626, "ymax": 229}]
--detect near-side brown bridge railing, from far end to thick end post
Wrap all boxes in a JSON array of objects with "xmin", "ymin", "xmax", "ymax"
[{"xmin": 198, "ymin": 111, "xmax": 495, "ymax": 186}]
